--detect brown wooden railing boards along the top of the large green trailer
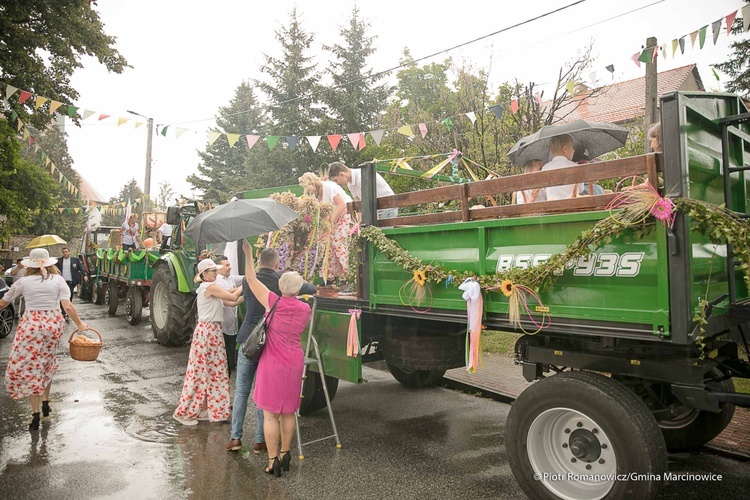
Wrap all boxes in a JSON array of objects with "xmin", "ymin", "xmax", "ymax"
[{"xmin": 349, "ymin": 153, "xmax": 662, "ymax": 226}]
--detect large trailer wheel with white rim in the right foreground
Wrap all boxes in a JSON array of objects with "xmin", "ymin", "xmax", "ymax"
[{"xmin": 505, "ymin": 371, "xmax": 667, "ymax": 500}]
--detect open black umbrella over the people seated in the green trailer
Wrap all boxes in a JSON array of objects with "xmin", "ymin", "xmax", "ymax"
[{"xmin": 508, "ymin": 120, "xmax": 628, "ymax": 166}]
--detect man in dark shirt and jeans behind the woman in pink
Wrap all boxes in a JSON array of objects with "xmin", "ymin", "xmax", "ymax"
[{"xmin": 227, "ymin": 248, "xmax": 317, "ymax": 454}]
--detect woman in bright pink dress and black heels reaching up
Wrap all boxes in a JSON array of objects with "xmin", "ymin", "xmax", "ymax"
[{"xmin": 242, "ymin": 241, "xmax": 310, "ymax": 477}]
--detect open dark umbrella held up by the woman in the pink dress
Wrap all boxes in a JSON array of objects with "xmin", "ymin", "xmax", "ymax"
[{"xmin": 185, "ymin": 198, "xmax": 299, "ymax": 244}]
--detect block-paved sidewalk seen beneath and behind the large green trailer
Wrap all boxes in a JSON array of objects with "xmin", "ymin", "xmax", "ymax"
[{"xmin": 443, "ymin": 353, "xmax": 750, "ymax": 459}]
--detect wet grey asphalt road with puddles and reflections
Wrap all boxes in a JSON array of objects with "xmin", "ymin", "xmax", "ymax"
[{"xmin": 0, "ymin": 302, "xmax": 750, "ymax": 500}]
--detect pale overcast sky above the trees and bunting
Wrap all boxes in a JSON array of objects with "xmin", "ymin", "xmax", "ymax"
[{"xmin": 66, "ymin": 0, "xmax": 748, "ymax": 203}]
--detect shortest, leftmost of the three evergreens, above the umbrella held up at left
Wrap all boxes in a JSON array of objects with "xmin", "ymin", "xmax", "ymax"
[{"xmin": 187, "ymin": 81, "xmax": 265, "ymax": 203}]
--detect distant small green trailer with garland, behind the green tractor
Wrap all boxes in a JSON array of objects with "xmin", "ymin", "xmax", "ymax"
[{"xmin": 93, "ymin": 248, "xmax": 160, "ymax": 325}]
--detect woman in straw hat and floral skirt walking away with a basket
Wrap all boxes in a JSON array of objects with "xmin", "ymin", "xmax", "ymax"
[{"xmin": 0, "ymin": 248, "xmax": 89, "ymax": 431}]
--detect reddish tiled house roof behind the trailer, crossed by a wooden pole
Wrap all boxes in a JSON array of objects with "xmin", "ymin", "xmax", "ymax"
[{"xmin": 555, "ymin": 64, "xmax": 705, "ymax": 123}]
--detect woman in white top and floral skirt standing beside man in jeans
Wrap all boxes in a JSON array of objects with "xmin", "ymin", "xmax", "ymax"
[{"xmin": 173, "ymin": 259, "xmax": 242, "ymax": 425}]
